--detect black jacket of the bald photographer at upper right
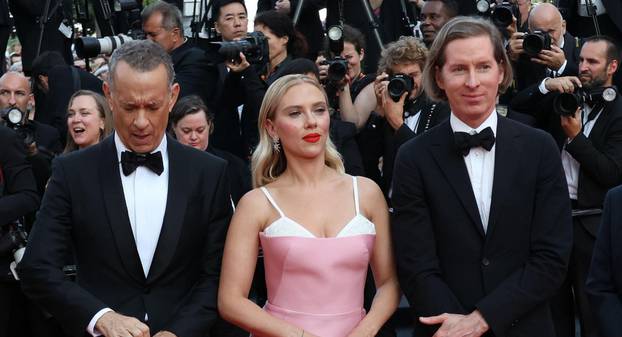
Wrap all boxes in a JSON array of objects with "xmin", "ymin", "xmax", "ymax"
[{"xmin": 516, "ymin": 33, "xmax": 581, "ymax": 91}]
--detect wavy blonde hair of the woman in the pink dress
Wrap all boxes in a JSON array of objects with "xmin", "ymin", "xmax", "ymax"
[{"xmin": 252, "ymin": 75, "xmax": 345, "ymax": 187}]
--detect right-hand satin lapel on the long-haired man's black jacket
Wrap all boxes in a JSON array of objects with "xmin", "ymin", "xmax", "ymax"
[{"xmin": 486, "ymin": 116, "xmax": 522, "ymax": 237}]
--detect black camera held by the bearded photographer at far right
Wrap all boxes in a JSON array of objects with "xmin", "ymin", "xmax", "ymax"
[{"xmin": 553, "ymin": 86, "xmax": 618, "ymax": 116}]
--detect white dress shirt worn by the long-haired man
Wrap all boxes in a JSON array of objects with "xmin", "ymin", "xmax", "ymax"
[{"xmin": 449, "ymin": 110, "xmax": 497, "ymax": 232}]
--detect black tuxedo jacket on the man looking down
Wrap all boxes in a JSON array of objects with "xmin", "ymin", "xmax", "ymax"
[{"xmin": 20, "ymin": 137, "xmax": 231, "ymax": 337}]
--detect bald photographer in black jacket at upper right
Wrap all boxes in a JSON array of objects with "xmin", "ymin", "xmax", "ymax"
[{"xmin": 509, "ymin": 3, "xmax": 580, "ymax": 90}]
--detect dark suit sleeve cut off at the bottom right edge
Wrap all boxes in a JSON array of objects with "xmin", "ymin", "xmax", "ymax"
[{"xmin": 586, "ymin": 187, "xmax": 622, "ymax": 337}]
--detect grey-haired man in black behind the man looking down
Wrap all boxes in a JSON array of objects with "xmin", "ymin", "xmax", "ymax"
[{"xmin": 141, "ymin": 1, "xmax": 215, "ymax": 105}]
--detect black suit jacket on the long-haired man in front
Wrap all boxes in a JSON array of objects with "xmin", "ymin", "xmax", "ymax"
[{"xmin": 392, "ymin": 117, "xmax": 572, "ymax": 337}]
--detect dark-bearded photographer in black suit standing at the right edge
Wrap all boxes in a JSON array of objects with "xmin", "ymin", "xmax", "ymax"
[{"xmin": 513, "ymin": 36, "xmax": 622, "ymax": 337}]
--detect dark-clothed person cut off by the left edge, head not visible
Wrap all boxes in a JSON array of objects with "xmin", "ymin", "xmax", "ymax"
[{"xmin": 0, "ymin": 126, "xmax": 39, "ymax": 337}]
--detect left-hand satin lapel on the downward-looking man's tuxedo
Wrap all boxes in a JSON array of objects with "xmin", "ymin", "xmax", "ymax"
[{"xmin": 99, "ymin": 136, "xmax": 145, "ymax": 283}]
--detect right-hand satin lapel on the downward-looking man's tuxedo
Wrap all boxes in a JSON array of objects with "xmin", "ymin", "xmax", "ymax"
[{"xmin": 147, "ymin": 137, "xmax": 192, "ymax": 283}]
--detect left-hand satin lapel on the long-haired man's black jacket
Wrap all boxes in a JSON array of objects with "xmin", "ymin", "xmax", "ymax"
[{"xmin": 432, "ymin": 121, "xmax": 485, "ymax": 237}]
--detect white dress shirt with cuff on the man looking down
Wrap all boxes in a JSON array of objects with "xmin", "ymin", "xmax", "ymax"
[{"xmin": 87, "ymin": 133, "xmax": 169, "ymax": 336}]
